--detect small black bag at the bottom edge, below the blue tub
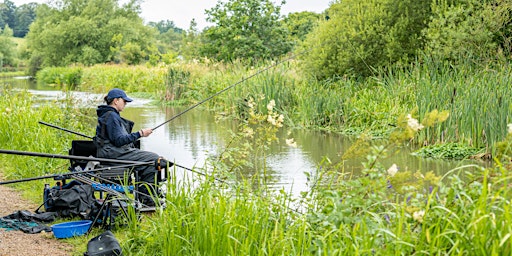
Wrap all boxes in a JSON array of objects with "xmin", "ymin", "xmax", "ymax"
[{"xmin": 84, "ymin": 230, "xmax": 123, "ymax": 256}]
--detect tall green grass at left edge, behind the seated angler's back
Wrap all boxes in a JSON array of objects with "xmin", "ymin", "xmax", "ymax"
[{"xmin": 0, "ymin": 86, "xmax": 91, "ymax": 196}]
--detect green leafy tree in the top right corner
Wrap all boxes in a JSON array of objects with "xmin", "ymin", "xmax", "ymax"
[{"xmin": 425, "ymin": 0, "xmax": 506, "ymax": 63}]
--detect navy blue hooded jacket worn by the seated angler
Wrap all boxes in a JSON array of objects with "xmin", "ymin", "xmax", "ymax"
[{"xmin": 96, "ymin": 105, "xmax": 140, "ymax": 147}]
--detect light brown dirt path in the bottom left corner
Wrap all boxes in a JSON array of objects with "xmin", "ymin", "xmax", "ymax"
[{"xmin": 0, "ymin": 183, "xmax": 73, "ymax": 256}]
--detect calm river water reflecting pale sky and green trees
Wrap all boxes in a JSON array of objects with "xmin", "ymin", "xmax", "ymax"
[{"xmin": 4, "ymin": 79, "xmax": 484, "ymax": 195}]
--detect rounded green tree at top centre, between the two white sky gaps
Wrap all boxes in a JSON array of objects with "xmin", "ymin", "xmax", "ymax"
[{"xmin": 201, "ymin": 0, "xmax": 292, "ymax": 61}]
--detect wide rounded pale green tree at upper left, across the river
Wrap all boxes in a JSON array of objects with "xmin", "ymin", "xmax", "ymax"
[{"xmin": 27, "ymin": 0, "xmax": 154, "ymax": 70}]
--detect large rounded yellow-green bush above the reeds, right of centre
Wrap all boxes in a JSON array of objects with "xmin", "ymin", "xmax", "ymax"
[{"xmin": 302, "ymin": 0, "xmax": 430, "ymax": 79}]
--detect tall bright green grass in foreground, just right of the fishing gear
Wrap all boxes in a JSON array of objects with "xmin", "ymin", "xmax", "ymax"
[{"xmin": 123, "ymin": 176, "xmax": 308, "ymax": 255}]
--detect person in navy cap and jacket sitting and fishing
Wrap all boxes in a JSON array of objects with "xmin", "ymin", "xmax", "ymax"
[{"xmin": 94, "ymin": 88, "xmax": 172, "ymax": 207}]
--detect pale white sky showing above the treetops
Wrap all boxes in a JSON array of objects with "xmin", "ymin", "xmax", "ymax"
[{"xmin": 11, "ymin": 0, "xmax": 331, "ymax": 29}]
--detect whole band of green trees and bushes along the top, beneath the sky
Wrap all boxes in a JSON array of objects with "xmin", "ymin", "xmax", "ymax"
[{"xmin": 4, "ymin": 0, "xmax": 512, "ymax": 79}]
